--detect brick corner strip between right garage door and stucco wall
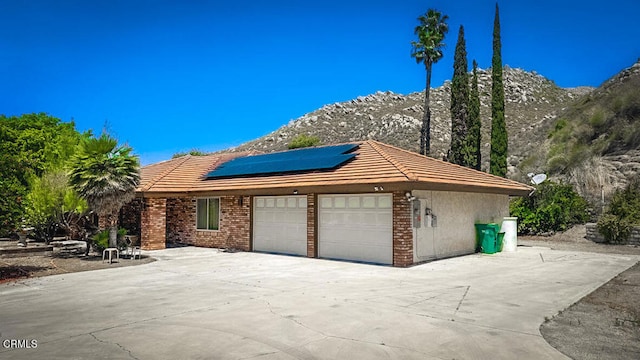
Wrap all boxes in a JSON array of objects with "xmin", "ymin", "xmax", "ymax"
[{"xmin": 393, "ymin": 191, "xmax": 413, "ymax": 267}]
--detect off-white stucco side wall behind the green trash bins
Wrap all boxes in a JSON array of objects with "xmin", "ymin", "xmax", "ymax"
[{"xmin": 412, "ymin": 190, "xmax": 509, "ymax": 262}]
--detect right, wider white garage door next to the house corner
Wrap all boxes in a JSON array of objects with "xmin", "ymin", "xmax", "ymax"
[{"xmin": 318, "ymin": 194, "xmax": 393, "ymax": 264}]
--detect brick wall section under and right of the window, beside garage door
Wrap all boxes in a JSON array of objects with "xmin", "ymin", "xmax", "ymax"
[{"xmin": 193, "ymin": 196, "xmax": 251, "ymax": 251}]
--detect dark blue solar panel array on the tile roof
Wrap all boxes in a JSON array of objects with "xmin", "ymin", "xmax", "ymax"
[{"xmin": 206, "ymin": 144, "xmax": 358, "ymax": 179}]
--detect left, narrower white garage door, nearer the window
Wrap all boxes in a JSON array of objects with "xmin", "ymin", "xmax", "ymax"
[{"xmin": 253, "ymin": 195, "xmax": 307, "ymax": 256}]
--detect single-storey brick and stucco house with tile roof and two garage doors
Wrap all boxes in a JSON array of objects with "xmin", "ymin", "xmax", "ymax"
[{"xmin": 121, "ymin": 140, "xmax": 533, "ymax": 267}]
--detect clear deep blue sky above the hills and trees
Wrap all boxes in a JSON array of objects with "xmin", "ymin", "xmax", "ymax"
[{"xmin": 0, "ymin": 0, "xmax": 640, "ymax": 164}]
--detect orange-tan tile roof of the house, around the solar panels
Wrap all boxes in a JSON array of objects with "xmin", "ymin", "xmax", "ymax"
[{"xmin": 138, "ymin": 140, "xmax": 533, "ymax": 195}]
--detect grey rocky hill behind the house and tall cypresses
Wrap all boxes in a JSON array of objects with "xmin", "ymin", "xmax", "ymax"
[{"xmin": 233, "ymin": 67, "xmax": 593, "ymax": 178}]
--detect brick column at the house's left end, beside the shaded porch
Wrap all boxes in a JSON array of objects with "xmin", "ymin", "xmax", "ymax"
[{"xmin": 140, "ymin": 198, "xmax": 167, "ymax": 250}]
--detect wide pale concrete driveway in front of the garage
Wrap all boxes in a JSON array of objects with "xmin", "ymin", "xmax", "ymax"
[{"xmin": 0, "ymin": 247, "xmax": 639, "ymax": 359}]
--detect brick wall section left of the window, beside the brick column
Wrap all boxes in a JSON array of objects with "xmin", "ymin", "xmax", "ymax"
[{"xmin": 167, "ymin": 197, "xmax": 196, "ymax": 245}]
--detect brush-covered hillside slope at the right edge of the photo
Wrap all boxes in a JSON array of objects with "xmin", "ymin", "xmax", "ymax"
[{"xmin": 520, "ymin": 59, "xmax": 640, "ymax": 204}]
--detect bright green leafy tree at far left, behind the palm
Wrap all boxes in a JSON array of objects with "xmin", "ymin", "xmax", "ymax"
[{"xmin": 0, "ymin": 113, "xmax": 88, "ymax": 236}]
